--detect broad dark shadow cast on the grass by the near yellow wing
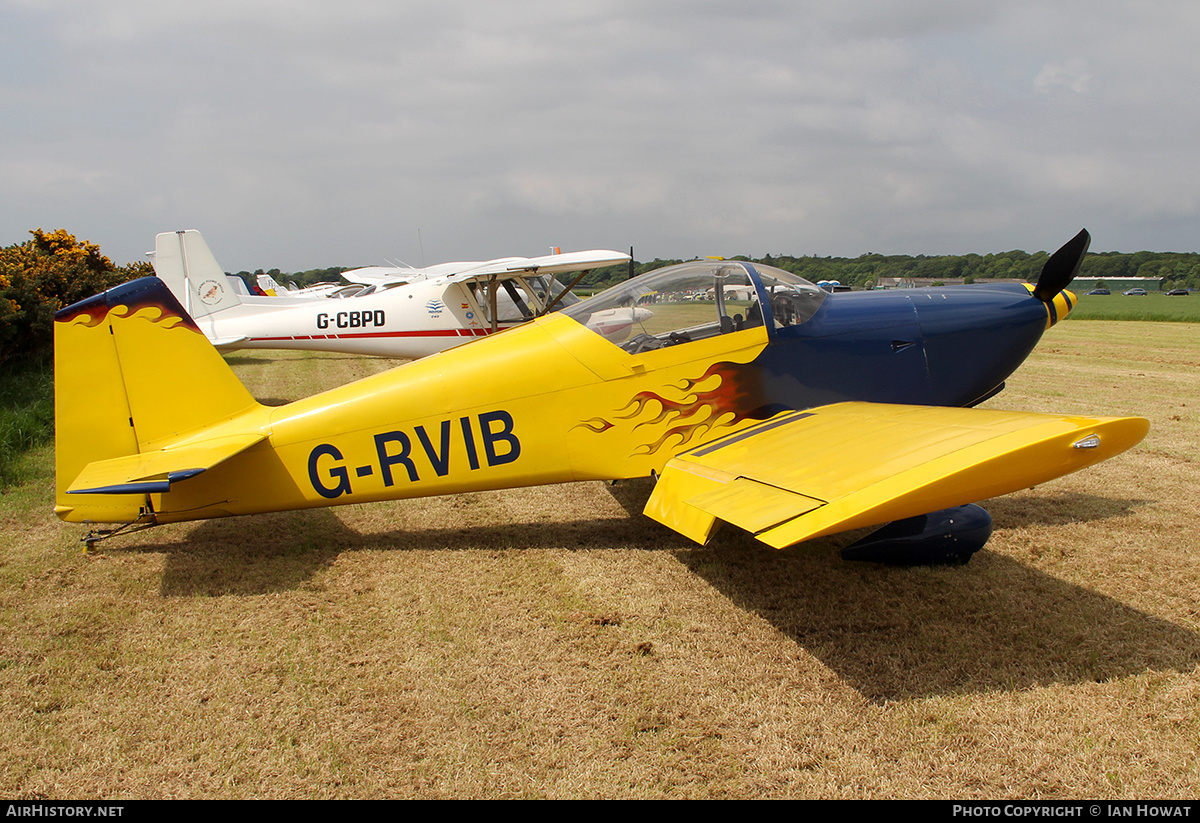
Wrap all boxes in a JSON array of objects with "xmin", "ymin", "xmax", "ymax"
[{"xmin": 680, "ymin": 493, "xmax": 1200, "ymax": 702}]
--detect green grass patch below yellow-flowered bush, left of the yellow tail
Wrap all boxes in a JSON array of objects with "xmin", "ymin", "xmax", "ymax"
[{"xmin": 0, "ymin": 353, "xmax": 54, "ymax": 488}]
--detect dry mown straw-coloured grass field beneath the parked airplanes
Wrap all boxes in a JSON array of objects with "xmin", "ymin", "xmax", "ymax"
[{"xmin": 0, "ymin": 321, "xmax": 1200, "ymax": 799}]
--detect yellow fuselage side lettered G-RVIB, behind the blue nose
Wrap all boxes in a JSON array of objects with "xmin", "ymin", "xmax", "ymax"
[{"xmin": 59, "ymin": 304, "xmax": 767, "ymax": 522}]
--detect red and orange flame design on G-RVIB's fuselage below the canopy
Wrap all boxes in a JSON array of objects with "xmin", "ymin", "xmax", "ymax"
[{"xmin": 580, "ymin": 361, "xmax": 762, "ymax": 455}]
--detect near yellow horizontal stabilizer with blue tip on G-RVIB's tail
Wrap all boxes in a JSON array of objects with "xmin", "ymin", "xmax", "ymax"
[{"xmin": 67, "ymin": 434, "xmax": 266, "ymax": 494}]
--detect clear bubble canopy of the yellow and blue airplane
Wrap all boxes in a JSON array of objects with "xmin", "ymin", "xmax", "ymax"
[{"xmin": 563, "ymin": 260, "xmax": 827, "ymax": 354}]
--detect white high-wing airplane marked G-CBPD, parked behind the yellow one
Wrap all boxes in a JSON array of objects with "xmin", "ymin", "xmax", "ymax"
[{"xmin": 154, "ymin": 229, "xmax": 652, "ymax": 358}]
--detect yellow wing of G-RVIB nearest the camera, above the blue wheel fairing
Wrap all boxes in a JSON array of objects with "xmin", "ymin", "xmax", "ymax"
[{"xmin": 646, "ymin": 403, "xmax": 1150, "ymax": 548}]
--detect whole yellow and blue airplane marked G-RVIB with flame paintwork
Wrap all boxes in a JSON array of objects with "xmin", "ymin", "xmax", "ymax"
[{"xmin": 55, "ymin": 230, "xmax": 1148, "ymax": 561}]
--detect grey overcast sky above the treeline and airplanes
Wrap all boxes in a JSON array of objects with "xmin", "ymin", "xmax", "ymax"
[{"xmin": 0, "ymin": 0, "xmax": 1200, "ymax": 271}]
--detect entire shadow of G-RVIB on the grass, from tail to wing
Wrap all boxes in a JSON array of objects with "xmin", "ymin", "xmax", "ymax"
[{"xmin": 117, "ymin": 483, "xmax": 1200, "ymax": 702}]
